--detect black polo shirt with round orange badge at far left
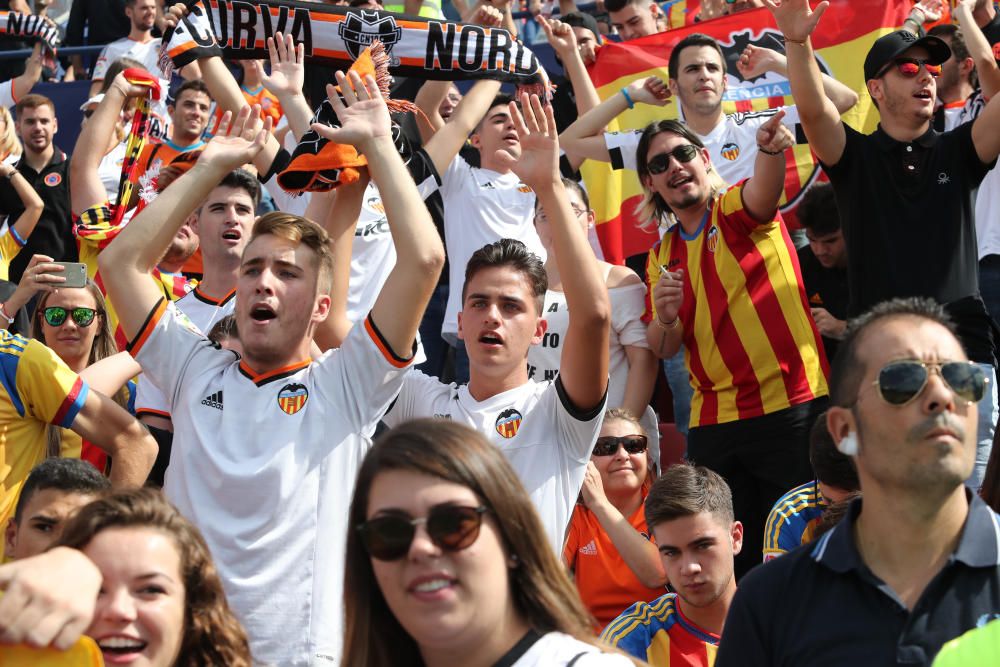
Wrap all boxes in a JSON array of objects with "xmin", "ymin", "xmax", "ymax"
[{"xmin": 0, "ymin": 148, "xmax": 77, "ymax": 283}]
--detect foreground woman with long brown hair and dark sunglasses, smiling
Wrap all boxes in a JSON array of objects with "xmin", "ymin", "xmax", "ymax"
[{"xmin": 341, "ymin": 419, "xmax": 634, "ymax": 667}]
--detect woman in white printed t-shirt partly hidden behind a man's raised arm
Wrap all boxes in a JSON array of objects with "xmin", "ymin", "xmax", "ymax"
[{"xmin": 528, "ymin": 178, "xmax": 659, "ymax": 451}]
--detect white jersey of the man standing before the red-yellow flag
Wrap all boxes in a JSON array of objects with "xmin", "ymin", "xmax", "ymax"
[{"xmin": 604, "ymin": 106, "xmax": 799, "ymax": 185}]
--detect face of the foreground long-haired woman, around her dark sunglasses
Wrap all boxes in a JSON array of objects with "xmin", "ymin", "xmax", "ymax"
[{"xmin": 367, "ymin": 470, "xmax": 513, "ymax": 651}]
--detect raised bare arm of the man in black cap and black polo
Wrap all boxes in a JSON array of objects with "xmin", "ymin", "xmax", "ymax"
[{"xmin": 764, "ymin": 0, "xmax": 847, "ymax": 165}]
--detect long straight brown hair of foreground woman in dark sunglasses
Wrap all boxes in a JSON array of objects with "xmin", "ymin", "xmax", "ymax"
[{"xmin": 341, "ymin": 419, "xmax": 628, "ymax": 667}]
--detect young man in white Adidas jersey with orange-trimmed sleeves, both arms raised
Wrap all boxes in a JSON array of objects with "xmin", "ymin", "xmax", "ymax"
[{"xmin": 101, "ymin": 73, "xmax": 444, "ymax": 666}]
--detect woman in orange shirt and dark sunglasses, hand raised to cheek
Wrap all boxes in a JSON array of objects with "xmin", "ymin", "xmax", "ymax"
[{"xmin": 563, "ymin": 408, "xmax": 667, "ymax": 630}]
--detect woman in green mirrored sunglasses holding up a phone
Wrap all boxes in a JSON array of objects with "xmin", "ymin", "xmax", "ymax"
[{"xmin": 29, "ymin": 280, "xmax": 142, "ymax": 473}]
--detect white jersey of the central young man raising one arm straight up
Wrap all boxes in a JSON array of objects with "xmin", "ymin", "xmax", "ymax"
[{"xmin": 384, "ymin": 371, "xmax": 605, "ymax": 554}]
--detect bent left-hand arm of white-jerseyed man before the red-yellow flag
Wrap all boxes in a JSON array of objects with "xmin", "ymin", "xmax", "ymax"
[{"xmin": 559, "ymin": 76, "xmax": 670, "ymax": 162}]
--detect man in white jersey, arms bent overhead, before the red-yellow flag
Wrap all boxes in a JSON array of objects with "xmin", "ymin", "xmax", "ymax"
[{"xmin": 559, "ymin": 33, "xmax": 858, "ymax": 185}]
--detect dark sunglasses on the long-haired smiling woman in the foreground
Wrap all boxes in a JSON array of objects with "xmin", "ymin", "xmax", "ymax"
[{"xmin": 358, "ymin": 505, "xmax": 487, "ymax": 561}]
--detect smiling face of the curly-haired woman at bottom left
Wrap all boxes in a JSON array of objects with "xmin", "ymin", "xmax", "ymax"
[{"xmin": 83, "ymin": 527, "xmax": 184, "ymax": 667}]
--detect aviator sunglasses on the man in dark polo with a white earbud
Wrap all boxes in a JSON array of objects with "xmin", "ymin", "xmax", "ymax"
[{"xmin": 872, "ymin": 360, "xmax": 987, "ymax": 405}]
